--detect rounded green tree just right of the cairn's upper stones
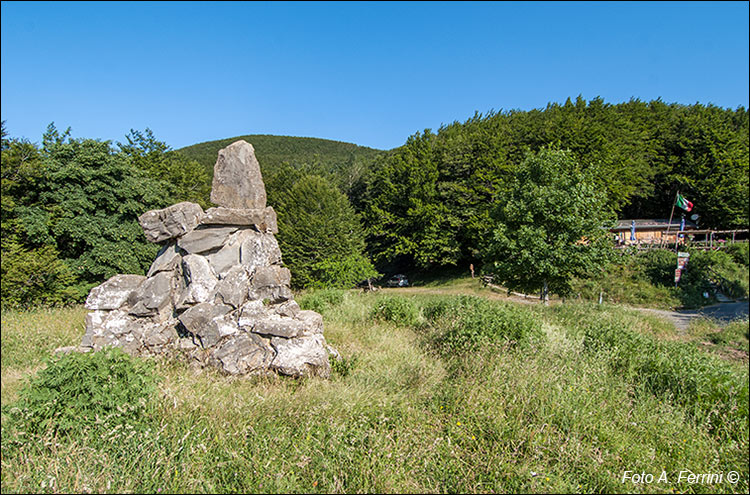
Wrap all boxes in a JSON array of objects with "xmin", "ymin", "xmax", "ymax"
[{"xmin": 275, "ymin": 175, "xmax": 377, "ymax": 288}]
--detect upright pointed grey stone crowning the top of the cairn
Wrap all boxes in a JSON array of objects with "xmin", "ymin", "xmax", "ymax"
[{"xmin": 211, "ymin": 141, "xmax": 266, "ymax": 209}]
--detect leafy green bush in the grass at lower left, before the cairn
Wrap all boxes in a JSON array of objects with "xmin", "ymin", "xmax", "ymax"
[{"xmin": 3, "ymin": 348, "xmax": 155, "ymax": 435}]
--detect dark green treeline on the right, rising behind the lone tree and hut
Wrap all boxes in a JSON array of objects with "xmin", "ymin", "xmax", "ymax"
[{"xmin": 362, "ymin": 97, "xmax": 749, "ymax": 276}]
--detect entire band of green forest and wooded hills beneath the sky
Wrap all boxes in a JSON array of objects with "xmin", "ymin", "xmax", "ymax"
[{"xmin": 2, "ymin": 97, "xmax": 750, "ymax": 306}]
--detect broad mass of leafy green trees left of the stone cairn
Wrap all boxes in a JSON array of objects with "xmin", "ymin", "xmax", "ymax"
[{"xmin": 2, "ymin": 124, "xmax": 169, "ymax": 305}]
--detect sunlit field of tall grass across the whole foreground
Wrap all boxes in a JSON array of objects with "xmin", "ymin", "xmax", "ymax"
[{"xmin": 2, "ymin": 279, "xmax": 749, "ymax": 493}]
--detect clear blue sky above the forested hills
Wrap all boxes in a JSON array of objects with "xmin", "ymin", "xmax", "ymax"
[{"xmin": 0, "ymin": 1, "xmax": 750, "ymax": 149}]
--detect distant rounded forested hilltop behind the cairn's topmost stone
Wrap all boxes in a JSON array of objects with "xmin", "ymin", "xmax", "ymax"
[{"xmin": 177, "ymin": 134, "xmax": 382, "ymax": 177}]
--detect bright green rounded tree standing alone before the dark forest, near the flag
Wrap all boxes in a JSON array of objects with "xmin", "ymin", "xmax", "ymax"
[{"xmin": 482, "ymin": 149, "xmax": 614, "ymax": 301}]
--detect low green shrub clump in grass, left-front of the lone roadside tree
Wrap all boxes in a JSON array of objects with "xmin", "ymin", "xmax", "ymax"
[{"xmin": 424, "ymin": 296, "xmax": 543, "ymax": 353}]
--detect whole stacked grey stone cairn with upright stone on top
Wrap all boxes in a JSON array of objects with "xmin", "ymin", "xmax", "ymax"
[{"xmin": 80, "ymin": 141, "xmax": 337, "ymax": 377}]
